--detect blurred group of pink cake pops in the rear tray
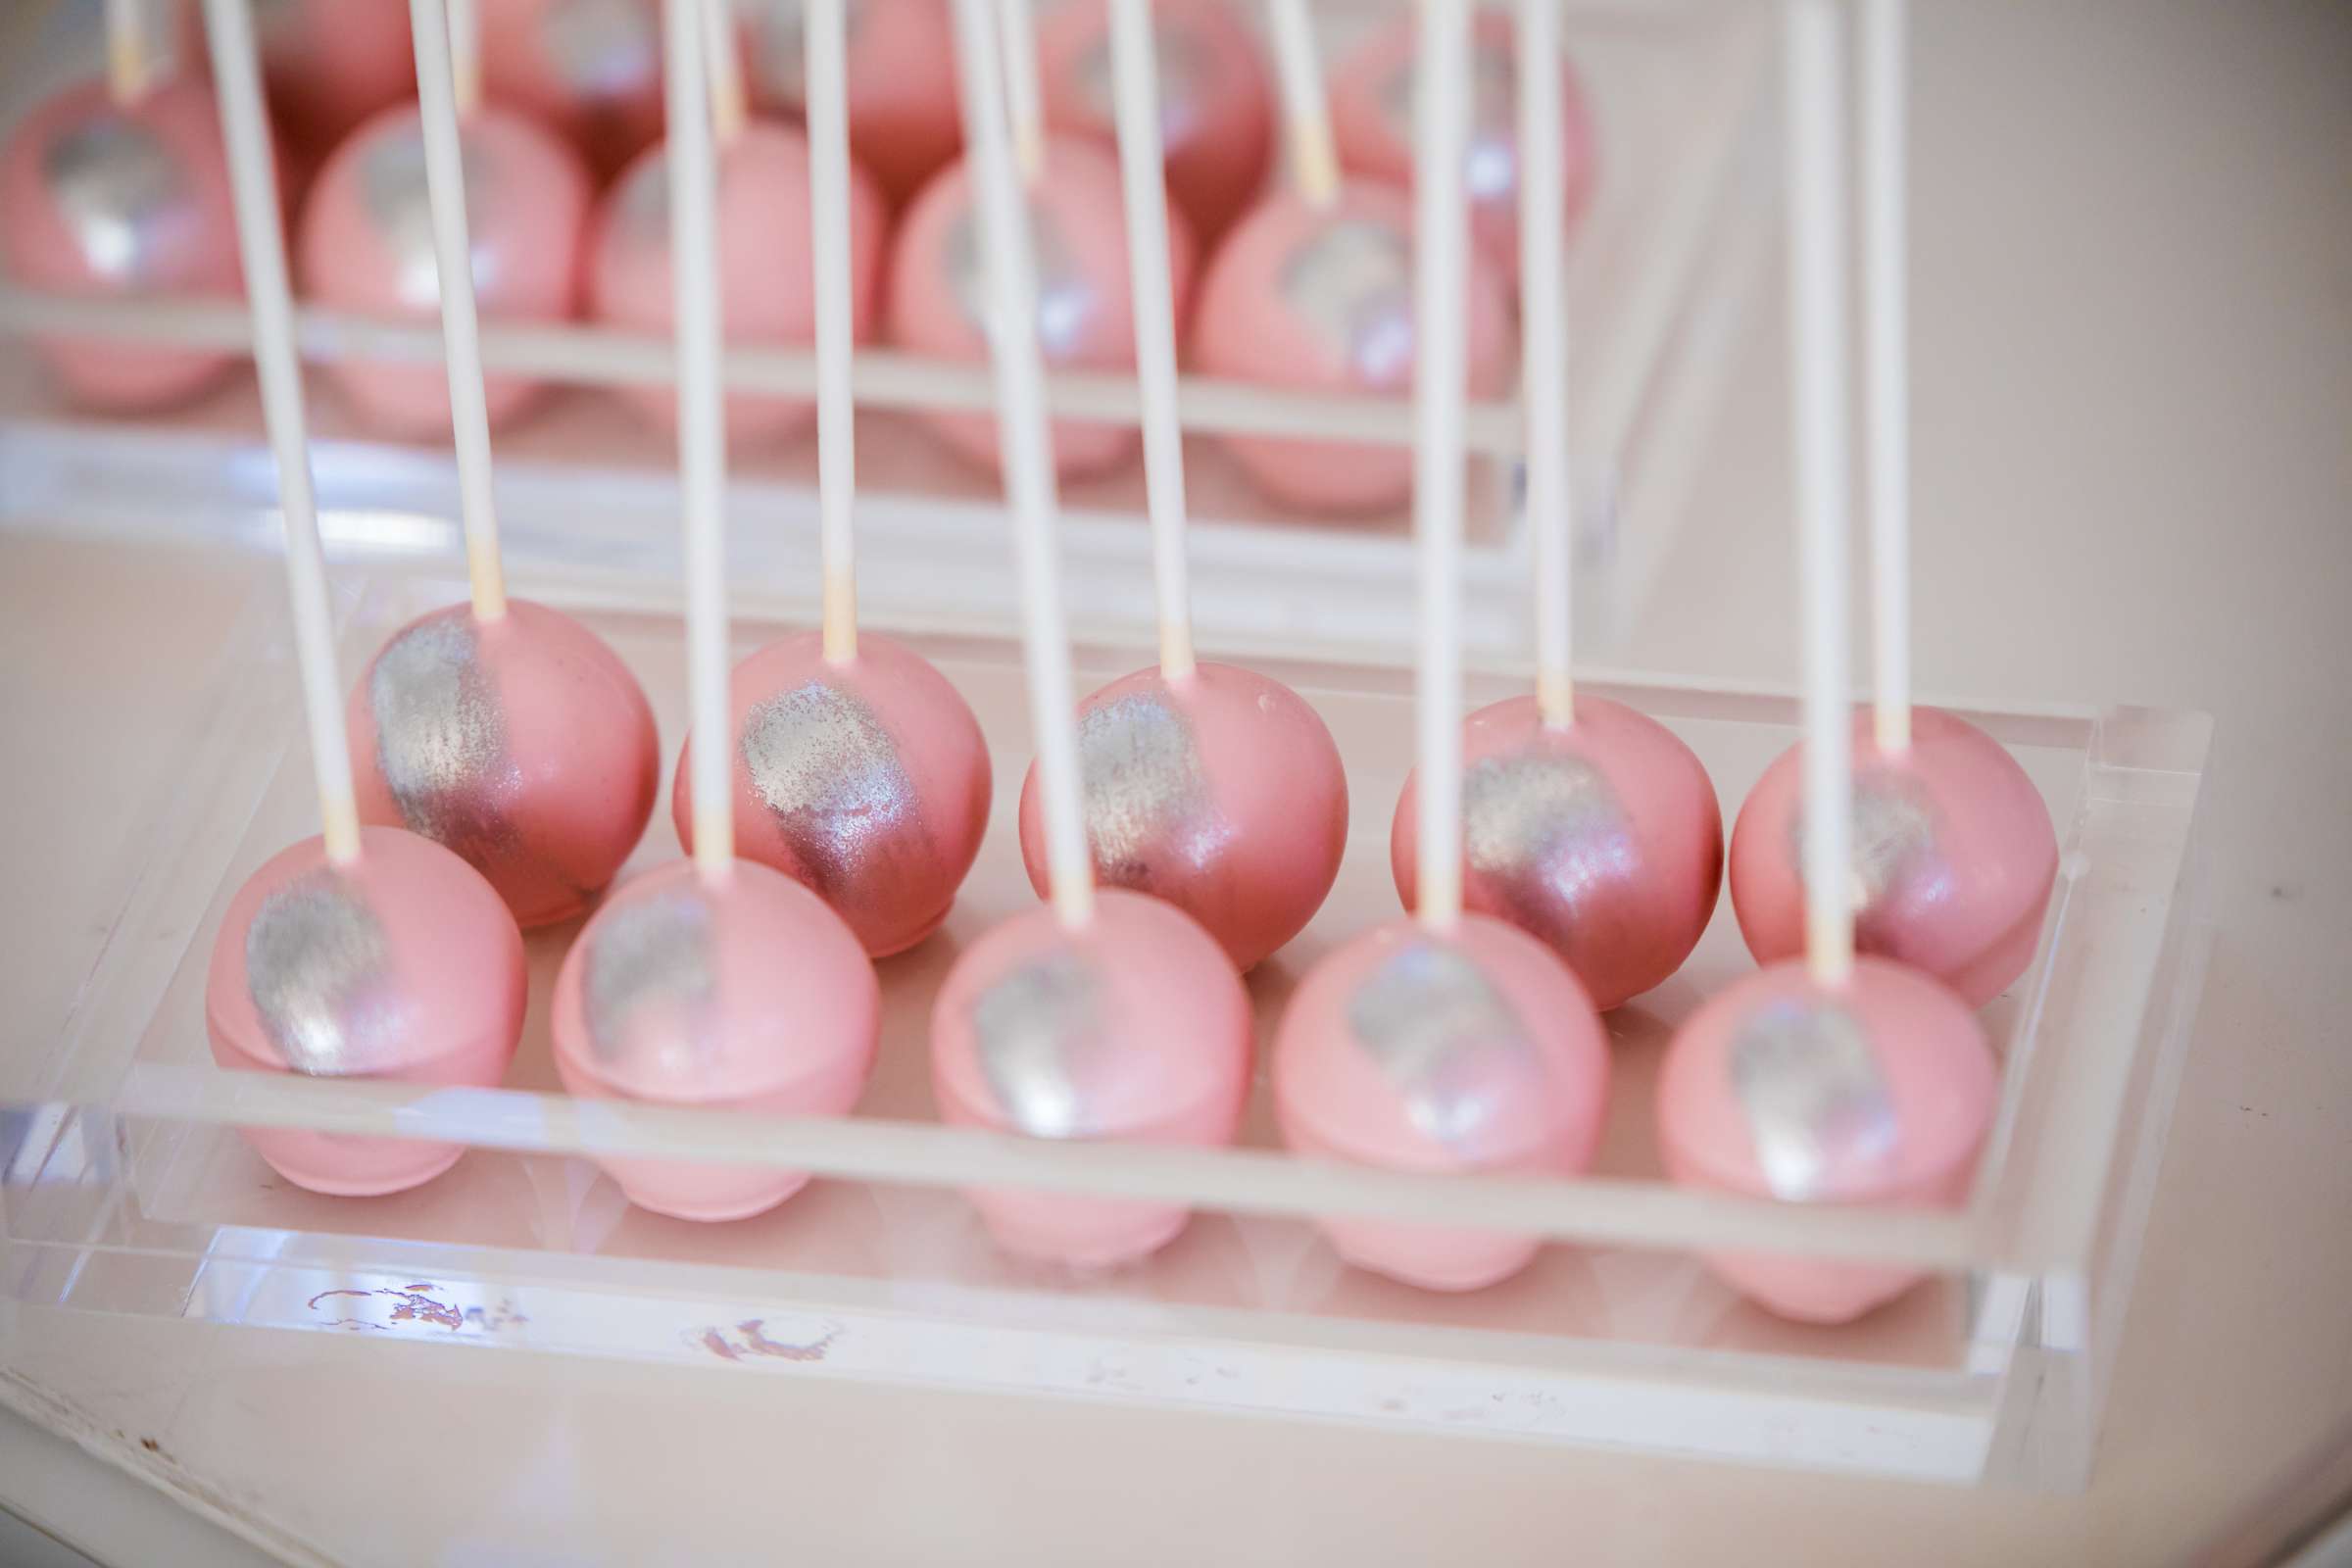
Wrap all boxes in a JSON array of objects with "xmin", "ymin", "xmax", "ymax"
[{"xmin": 5, "ymin": 0, "xmax": 1592, "ymax": 511}]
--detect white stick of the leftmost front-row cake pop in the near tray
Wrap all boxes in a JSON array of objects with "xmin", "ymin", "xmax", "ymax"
[{"xmin": 205, "ymin": 0, "xmax": 360, "ymax": 865}]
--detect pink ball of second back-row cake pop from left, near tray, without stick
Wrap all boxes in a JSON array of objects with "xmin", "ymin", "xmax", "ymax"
[{"xmin": 670, "ymin": 632, "xmax": 993, "ymax": 956}]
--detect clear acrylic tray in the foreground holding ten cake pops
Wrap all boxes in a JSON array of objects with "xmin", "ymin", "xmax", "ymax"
[{"xmin": 0, "ymin": 557, "xmax": 2209, "ymax": 1486}]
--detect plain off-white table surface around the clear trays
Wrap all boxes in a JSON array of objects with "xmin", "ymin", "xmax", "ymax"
[{"xmin": 0, "ymin": 0, "xmax": 2352, "ymax": 1563}]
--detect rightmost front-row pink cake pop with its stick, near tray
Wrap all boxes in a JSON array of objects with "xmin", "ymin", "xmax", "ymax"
[{"xmin": 1658, "ymin": 0, "xmax": 1999, "ymax": 1324}]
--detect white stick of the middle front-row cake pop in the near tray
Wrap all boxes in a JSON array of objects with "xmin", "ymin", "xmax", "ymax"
[{"xmin": 955, "ymin": 0, "xmax": 1094, "ymax": 931}]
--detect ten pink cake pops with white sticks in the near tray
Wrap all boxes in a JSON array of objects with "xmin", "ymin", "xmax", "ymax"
[{"xmin": 192, "ymin": 0, "xmax": 2053, "ymax": 1316}]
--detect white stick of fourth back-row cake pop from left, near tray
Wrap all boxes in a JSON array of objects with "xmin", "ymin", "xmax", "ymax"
[{"xmin": 1519, "ymin": 0, "xmax": 1576, "ymax": 726}]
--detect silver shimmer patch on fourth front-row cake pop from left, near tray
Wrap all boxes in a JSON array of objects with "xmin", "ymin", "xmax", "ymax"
[{"xmin": 1348, "ymin": 941, "xmax": 1541, "ymax": 1156}]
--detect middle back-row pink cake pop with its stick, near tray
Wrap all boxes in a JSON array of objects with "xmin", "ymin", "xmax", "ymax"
[{"xmin": 1021, "ymin": 0, "xmax": 1348, "ymax": 968}]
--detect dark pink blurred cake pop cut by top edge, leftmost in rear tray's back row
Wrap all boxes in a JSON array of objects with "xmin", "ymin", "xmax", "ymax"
[{"xmin": 181, "ymin": 0, "xmax": 416, "ymax": 151}]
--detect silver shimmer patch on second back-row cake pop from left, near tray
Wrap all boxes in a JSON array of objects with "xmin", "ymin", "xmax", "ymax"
[{"xmin": 741, "ymin": 679, "xmax": 931, "ymax": 898}]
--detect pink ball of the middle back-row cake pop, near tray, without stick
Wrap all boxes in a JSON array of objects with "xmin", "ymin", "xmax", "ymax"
[{"xmin": 1021, "ymin": 662, "xmax": 1348, "ymax": 971}]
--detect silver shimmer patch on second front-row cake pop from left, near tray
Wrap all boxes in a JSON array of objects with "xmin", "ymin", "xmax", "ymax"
[{"xmin": 581, "ymin": 889, "xmax": 717, "ymax": 1079}]
